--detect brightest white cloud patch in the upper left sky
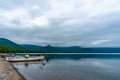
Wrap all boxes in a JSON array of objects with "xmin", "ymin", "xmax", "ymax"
[{"xmin": 0, "ymin": 6, "xmax": 49, "ymax": 28}]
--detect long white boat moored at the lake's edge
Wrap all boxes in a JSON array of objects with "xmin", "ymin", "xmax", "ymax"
[{"xmin": 6, "ymin": 56, "xmax": 45, "ymax": 62}]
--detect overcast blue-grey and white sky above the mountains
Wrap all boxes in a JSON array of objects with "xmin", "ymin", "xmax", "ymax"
[{"xmin": 0, "ymin": 0, "xmax": 120, "ymax": 47}]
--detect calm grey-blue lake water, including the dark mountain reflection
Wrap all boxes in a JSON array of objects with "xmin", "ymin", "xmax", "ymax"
[{"xmin": 13, "ymin": 54, "xmax": 120, "ymax": 80}]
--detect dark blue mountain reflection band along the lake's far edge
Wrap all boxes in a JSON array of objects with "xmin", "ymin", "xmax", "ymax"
[{"xmin": 45, "ymin": 53, "xmax": 120, "ymax": 61}]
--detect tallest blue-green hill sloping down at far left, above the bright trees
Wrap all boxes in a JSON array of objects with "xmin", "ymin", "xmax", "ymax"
[{"xmin": 0, "ymin": 38, "xmax": 24, "ymax": 50}]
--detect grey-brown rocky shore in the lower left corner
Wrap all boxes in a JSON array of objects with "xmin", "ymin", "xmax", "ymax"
[{"xmin": 0, "ymin": 58, "xmax": 25, "ymax": 80}]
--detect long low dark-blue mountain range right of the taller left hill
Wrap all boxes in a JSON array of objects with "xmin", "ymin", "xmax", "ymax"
[{"xmin": 21, "ymin": 44, "xmax": 120, "ymax": 53}]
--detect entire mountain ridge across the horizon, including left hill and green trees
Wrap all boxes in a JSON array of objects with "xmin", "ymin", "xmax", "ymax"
[{"xmin": 0, "ymin": 38, "xmax": 120, "ymax": 53}]
